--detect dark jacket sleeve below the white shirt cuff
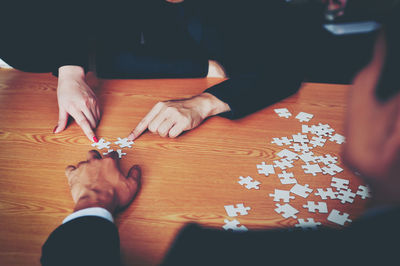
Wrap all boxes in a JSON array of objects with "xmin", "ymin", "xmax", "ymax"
[{"xmin": 40, "ymin": 216, "xmax": 120, "ymax": 266}]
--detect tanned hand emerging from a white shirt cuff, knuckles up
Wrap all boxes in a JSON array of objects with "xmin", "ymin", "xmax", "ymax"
[{"xmin": 65, "ymin": 150, "xmax": 141, "ymax": 213}]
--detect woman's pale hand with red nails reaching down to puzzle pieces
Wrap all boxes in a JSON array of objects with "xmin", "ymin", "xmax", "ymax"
[{"xmin": 54, "ymin": 66, "xmax": 100, "ymax": 142}]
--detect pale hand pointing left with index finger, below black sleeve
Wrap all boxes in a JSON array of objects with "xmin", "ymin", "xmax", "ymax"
[{"xmin": 128, "ymin": 93, "xmax": 230, "ymax": 140}]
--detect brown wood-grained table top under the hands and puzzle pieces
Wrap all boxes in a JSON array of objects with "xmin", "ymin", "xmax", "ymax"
[{"xmin": 0, "ymin": 70, "xmax": 367, "ymax": 265}]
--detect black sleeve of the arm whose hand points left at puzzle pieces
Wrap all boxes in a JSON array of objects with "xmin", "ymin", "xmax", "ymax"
[{"xmin": 205, "ymin": 2, "xmax": 313, "ymax": 119}]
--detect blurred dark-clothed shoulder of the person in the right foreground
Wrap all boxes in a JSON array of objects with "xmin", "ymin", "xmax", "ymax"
[{"xmin": 163, "ymin": 208, "xmax": 400, "ymax": 266}]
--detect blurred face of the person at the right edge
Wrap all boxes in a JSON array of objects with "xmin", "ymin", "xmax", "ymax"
[{"xmin": 343, "ymin": 31, "xmax": 400, "ymax": 204}]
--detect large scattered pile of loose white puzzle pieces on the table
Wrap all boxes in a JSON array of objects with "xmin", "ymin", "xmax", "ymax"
[{"xmin": 223, "ymin": 108, "xmax": 371, "ymax": 232}]
